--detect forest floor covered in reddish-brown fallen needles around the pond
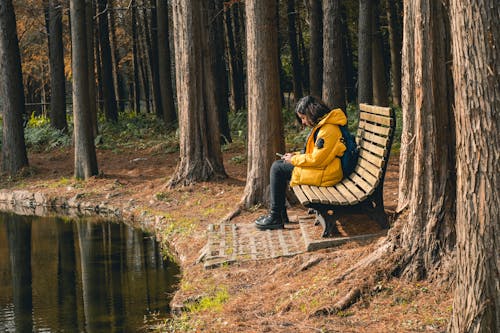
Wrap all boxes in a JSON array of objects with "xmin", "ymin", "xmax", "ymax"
[{"xmin": 0, "ymin": 144, "xmax": 452, "ymax": 332}]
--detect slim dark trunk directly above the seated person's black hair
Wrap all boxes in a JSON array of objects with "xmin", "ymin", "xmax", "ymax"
[{"xmin": 309, "ymin": 0, "xmax": 323, "ymax": 97}]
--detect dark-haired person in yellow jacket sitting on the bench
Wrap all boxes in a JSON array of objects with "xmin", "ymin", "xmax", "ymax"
[{"xmin": 255, "ymin": 96, "xmax": 347, "ymax": 230}]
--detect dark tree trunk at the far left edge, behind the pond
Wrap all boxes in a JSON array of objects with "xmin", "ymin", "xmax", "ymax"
[{"xmin": 0, "ymin": 0, "xmax": 28, "ymax": 175}]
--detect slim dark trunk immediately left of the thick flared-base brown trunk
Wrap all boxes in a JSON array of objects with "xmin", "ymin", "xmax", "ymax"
[{"xmin": 156, "ymin": 0, "xmax": 177, "ymax": 127}]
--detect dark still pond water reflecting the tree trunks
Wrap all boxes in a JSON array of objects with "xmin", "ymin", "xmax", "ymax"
[{"xmin": 0, "ymin": 212, "xmax": 179, "ymax": 333}]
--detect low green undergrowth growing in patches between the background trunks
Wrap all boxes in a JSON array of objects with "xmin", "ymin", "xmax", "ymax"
[{"xmin": 0, "ymin": 104, "xmax": 402, "ymax": 154}]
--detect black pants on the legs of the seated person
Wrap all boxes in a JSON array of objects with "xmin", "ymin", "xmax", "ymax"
[{"xmin": 270, "ymin": 160, "xmax": 293, "ymax": 214}]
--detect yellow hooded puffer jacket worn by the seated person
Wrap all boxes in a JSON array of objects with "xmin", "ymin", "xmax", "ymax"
[{"xmin": 290, "ymin": 109, "xmax": 347, "ymax": 186}]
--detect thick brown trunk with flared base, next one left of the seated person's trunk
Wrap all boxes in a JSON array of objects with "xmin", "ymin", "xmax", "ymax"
[{"xmin": 169, "ymin": 0, "xmax": 226, "ymax": 186}]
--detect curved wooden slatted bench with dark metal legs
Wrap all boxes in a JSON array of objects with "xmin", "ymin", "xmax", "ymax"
[{"xmin": 292, "ymin": 104, "xmax": 396, "ymax": 237}]
